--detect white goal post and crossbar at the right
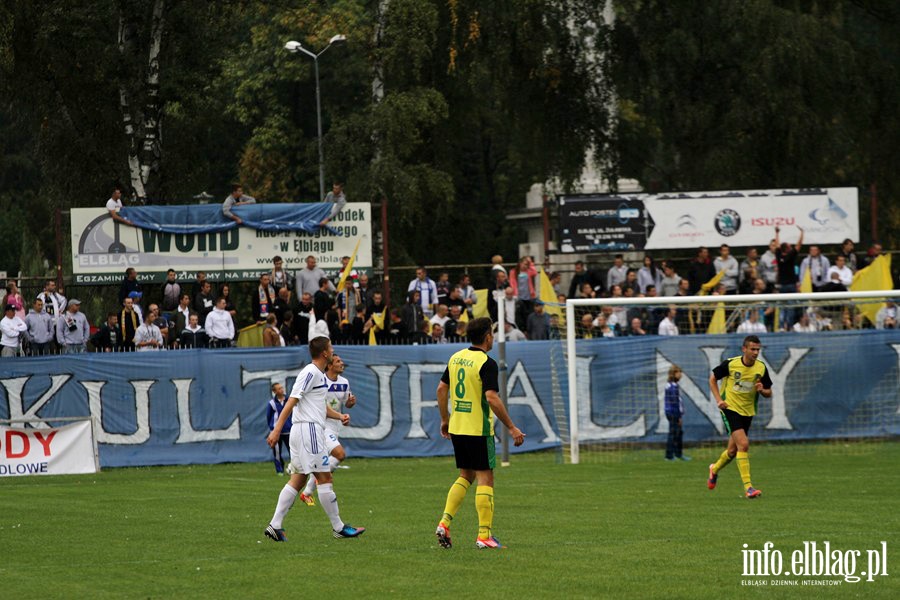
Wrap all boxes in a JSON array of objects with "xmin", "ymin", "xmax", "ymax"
[{"xmin": 563, "ymin": 290, "xmax": 900, "ymax": 464}]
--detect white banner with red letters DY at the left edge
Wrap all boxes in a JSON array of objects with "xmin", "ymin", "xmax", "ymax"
[{"xmin": 0, "ymin": 420, "xmax": 97, "ymax": 477}]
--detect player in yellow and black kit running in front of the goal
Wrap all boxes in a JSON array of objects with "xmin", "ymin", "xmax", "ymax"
[{"xmin": 707, "ymin": 335, "xmax": 772, "ymax": 498}]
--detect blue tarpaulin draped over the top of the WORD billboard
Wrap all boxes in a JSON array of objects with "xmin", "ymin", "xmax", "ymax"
[{"xmin": 121, "ymin": 202, "xmax": 337, "ymax": 234}]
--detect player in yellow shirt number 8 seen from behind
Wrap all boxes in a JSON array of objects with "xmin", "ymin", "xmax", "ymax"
[{"xmin": 436, "ymin": 318, "xmax": 525, "ymax": 548}]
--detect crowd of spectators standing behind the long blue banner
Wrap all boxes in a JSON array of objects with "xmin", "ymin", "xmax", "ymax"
[{"xmin": 0, "ymin": 226, "xmax": 898, "ymax": 357}]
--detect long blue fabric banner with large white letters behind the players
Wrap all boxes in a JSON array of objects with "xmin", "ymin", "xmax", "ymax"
[{"xmin": 0, "ymin": 330, "xmax": 900, "ymax": 467}]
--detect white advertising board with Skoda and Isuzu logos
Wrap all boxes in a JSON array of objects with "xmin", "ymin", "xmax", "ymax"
[{"xmin": 645, "ymin": 188, "xmax": 859, "ymax": 250}]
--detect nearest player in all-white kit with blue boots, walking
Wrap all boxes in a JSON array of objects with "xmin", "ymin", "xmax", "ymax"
[{"xmin": 266, "ymin": 337, "xmax": 366, "ymax": 542}]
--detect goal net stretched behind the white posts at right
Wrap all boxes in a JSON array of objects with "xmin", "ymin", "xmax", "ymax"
[{"xmin": 556, "ymin": 291, "xmax": 900, "ymax": 463}]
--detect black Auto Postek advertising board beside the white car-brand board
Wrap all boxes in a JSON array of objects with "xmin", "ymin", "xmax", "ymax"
[{"xmin": 558, "ymin": 194, "xmax": 647, "ymax": 253}]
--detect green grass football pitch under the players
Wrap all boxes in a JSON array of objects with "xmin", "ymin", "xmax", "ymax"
[{"xmin": 0, "ymin": 442, "xmax": 900, "ymax": 599}]
